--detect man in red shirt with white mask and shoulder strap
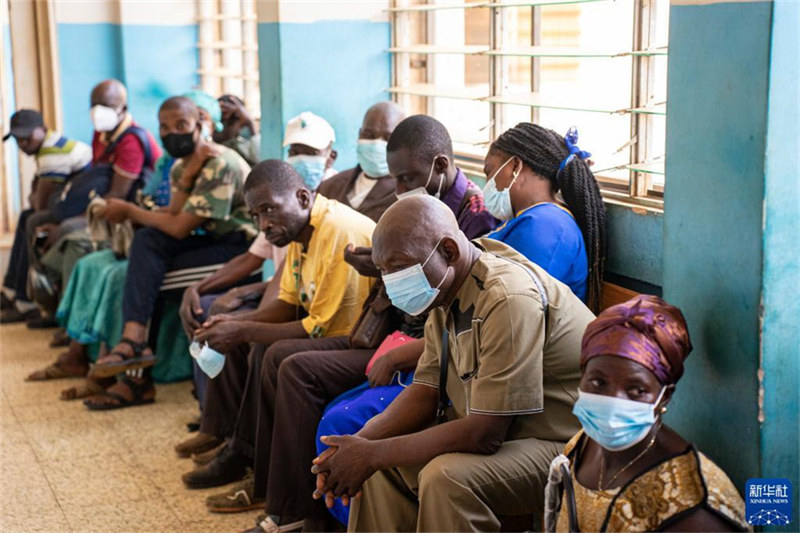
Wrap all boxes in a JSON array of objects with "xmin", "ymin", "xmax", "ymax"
[{"xmin": 26, "ymin": 79, "xmax": 161, "ymax": 327}]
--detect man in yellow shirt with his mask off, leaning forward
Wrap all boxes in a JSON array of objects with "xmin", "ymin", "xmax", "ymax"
[{"xmin": 183, "ymin": 160, "xmax": 375, "ymax": 488}]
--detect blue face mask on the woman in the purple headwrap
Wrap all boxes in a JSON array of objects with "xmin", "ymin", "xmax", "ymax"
[{"xmin": 572, "ymin": 387, "xmax": 666, "ymax": 452}]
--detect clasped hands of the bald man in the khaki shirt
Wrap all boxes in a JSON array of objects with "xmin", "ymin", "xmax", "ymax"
[{"xmin": 311, "ymin": 435, "xmax": 378, "ymax": 509}]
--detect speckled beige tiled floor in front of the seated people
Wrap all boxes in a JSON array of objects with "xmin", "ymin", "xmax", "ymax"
[{"xmin": 0, "ymin": 325, "xmax": 258, "ymax": 533}]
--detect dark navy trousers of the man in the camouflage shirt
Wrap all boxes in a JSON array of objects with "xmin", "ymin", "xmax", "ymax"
[{"xmin": 122, "ymin": 228, "xmax": 248, "ymax": 324}]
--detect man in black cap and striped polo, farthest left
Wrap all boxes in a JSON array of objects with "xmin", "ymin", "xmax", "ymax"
[{"xmin": 0, "ymin": 109, "xmax": 92, "ymax": 324}]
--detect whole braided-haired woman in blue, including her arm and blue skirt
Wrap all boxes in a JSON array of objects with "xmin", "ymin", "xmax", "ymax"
[{"xmin": 317, "ymin": 123, "xmax": 606, "ymax": 523}]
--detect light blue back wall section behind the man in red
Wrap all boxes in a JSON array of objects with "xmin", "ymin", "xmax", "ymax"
[{"xmin": 58, "ymin": 23, "xmax": 198, "ymax": 142}]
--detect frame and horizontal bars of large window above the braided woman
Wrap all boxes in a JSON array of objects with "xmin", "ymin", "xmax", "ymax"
[{"xmin": 387, "ymin": 0, "xmax": 668, "ymax": 205}]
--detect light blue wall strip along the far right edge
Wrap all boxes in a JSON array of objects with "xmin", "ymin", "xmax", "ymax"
[{"xmin": 761, "ymin": 2, "xmax": 800, "ymax": 523}]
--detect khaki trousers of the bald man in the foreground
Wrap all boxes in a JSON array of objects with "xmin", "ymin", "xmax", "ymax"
[{"xmin": 348, "ymin": 438, "xmax": 564, "ymax": 531}]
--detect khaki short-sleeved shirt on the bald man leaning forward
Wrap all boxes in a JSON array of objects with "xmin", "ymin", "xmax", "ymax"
[{"xmin": 414, "ymin": 239, "xmax": 594, "ymax": 442}]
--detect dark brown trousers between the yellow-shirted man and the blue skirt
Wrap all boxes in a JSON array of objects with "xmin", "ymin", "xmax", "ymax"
[{"xmin": 201, "ymin": 337, "xmax": 375, "ymax": 518}]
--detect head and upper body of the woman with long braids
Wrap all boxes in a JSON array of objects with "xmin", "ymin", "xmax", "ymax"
[{"xmin": 483, "ymin": 122, "xmax": 606, "ymax": 313}]
